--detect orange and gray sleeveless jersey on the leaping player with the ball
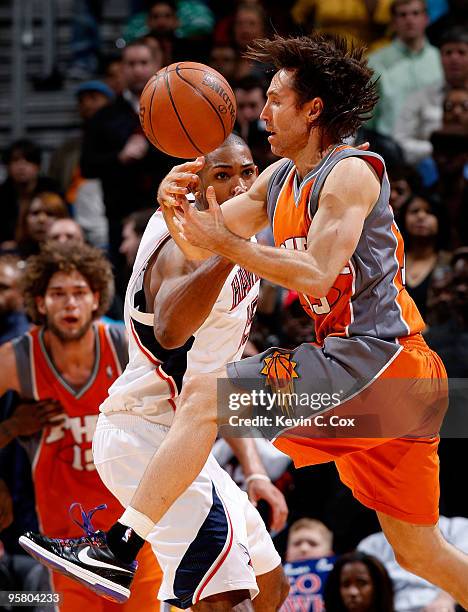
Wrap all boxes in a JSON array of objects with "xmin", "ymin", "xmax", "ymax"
[{"xmin": 267, "ymin": 145, "xmax": 424, "ymax": 345}]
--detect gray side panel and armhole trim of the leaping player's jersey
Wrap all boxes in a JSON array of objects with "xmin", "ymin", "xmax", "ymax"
[{"xmin": 309, "ymin": 149, "xmax": 409, "ymax": 340}]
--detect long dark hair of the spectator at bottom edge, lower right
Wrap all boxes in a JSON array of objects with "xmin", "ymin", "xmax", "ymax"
[{"xmin": 323, "ymin": 551, "xmax": 395, "ymax": 612}]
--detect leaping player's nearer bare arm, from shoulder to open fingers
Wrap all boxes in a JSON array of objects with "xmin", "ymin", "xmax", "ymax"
[{"xmin": 174, "ymin": 157, "xmax": 380, "ymax": 298}]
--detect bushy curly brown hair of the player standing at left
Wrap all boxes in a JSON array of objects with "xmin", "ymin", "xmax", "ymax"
[{"xmin": 21, "ymin": 241, "xmax": 114, "ymax": 325}]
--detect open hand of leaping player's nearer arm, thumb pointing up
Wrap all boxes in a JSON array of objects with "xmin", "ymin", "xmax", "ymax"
[{"xmin": 175, "ymin": 186, "xmax": 230, "ymax": 253}]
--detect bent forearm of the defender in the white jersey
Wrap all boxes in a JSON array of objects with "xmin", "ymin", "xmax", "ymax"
[{"xmin": 154, "ymin": 257, "xmax": 234, "ymax": 349}]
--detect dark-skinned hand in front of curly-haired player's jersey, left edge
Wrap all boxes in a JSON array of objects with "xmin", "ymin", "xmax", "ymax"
[{"xmin": 9, "ymin": 399, "xmax": 65, "ymax": 436}]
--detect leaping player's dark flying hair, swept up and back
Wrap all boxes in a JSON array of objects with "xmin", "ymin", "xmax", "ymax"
[{"xmin": 244, "ymin": 33, "xmax": 378, "ymax": 143}]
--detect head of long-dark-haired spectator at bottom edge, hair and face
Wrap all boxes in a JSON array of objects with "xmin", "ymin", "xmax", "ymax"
[{"xmin": 324, "ymin": 552, "xmax": 395, "ymax": 612}]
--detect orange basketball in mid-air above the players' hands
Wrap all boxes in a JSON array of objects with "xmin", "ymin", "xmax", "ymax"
[{"xmin": 140, "ymin": 62, "xmax": 237, "ymax": 158}]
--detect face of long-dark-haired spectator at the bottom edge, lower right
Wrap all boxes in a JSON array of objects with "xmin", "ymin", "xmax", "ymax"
[{"xmin": 340, "ymin": 561, "xmax": 374, "ymax": 612}]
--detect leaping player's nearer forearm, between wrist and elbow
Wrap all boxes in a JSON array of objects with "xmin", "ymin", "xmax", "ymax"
[{"xmin": 213, "ymin": 232, "xmax": 328, "ymax": 298}]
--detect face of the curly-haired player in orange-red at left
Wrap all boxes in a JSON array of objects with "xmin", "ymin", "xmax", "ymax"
[{"xmin": 36, "ymin": 271, "xmax": 99, "ymax": 342}]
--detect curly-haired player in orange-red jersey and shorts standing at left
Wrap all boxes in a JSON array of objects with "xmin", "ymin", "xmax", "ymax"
[{"xmin": 0, "ymin": 242, "xmax": 161, "ymax": 612}]
